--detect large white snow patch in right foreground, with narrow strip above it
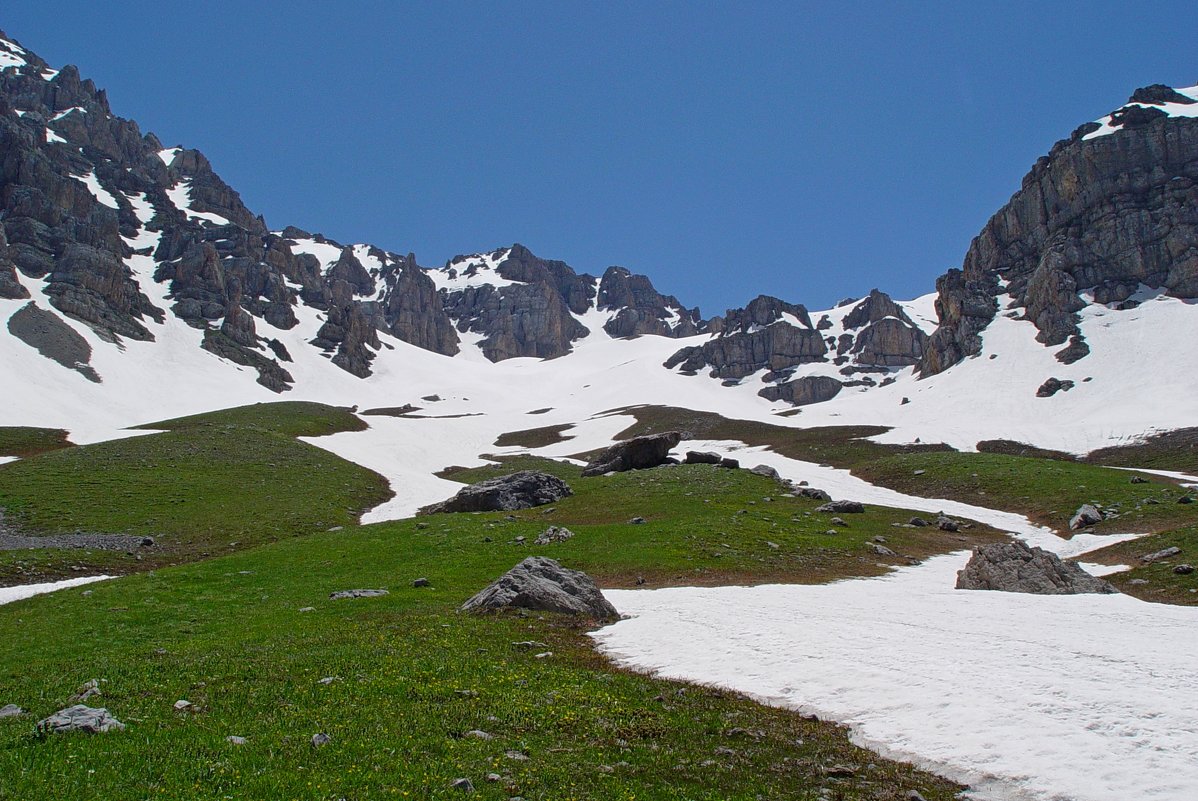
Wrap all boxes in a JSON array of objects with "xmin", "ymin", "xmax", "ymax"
[{"xmin": 593, "ymin": 443, "xmax": 1198, "ymax": 801}]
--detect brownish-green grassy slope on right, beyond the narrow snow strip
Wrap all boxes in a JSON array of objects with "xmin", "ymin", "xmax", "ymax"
[{"xmin": 608, "ymin": 407, "xmax": 1198, "ymax": 605}]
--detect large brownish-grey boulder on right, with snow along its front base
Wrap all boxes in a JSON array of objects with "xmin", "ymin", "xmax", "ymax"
[{"xmin": 957, "ymin": 540, "xmax": 1119, "ymax": 595}]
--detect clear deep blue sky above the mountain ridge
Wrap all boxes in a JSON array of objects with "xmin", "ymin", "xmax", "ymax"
[{"xmin": 0, "ymin": 0, "xmax": 1198, "ymax": 315}]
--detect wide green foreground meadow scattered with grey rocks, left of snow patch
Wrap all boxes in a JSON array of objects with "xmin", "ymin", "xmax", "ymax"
[{"xmin": 0, "ymin": 411, "xmax": 1001, "ymax": 800}]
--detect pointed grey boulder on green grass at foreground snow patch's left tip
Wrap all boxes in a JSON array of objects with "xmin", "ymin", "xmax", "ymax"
[{"xmin": 461, "ymin": 557, "xmax": 619, "ymax": 620}]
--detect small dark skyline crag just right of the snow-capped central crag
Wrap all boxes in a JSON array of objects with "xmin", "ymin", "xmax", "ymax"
[{"xmin": 597, "ymin": 267, "xmax": 703, "ymax": 338}]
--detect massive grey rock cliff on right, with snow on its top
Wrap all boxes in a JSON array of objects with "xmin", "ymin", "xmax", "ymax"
[{"xmin": 919, "ymin": 86, "xmax": 1198, "ymax": 376}]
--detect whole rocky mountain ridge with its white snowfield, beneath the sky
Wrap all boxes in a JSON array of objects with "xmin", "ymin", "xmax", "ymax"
[{"xmin": 0, "ymin": 34, "xmax": 1198, "ymax": 454}]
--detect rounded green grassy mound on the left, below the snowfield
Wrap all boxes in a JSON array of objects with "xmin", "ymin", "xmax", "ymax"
[{"xmin": 0, "ymin": 403, "xmax": 389, "ymax": 583}]
